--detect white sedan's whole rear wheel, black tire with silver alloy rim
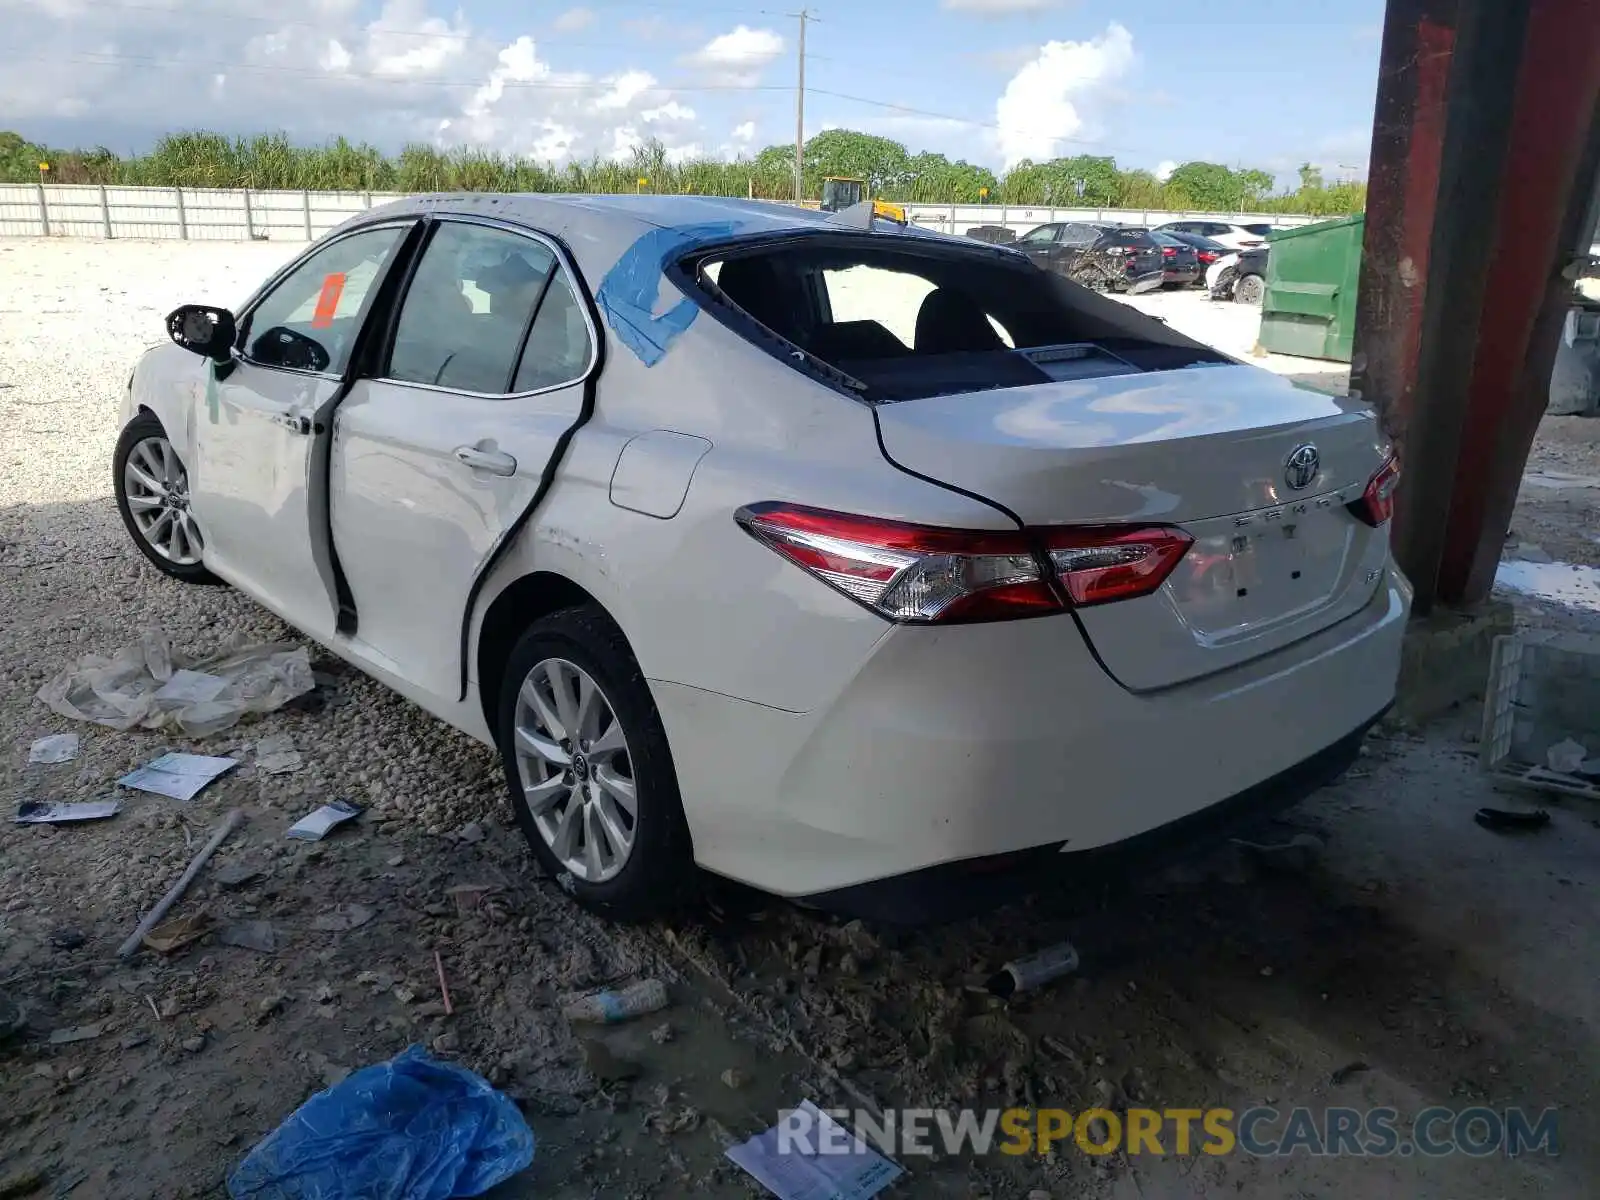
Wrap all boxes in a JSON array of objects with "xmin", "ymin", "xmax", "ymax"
[{"xmin": 498, "ymin": 605, "xmax": 694, "ymax": 920}]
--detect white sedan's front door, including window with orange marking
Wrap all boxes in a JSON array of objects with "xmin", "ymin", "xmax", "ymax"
[{"xmin": 190, "ymin": 222, "xmax": 411, "ymax": 637}]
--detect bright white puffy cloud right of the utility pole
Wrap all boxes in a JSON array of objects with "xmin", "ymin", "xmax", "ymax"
[{"xmin": 995, "ymin": 21, "xmax": 1134, "ymax": 168}]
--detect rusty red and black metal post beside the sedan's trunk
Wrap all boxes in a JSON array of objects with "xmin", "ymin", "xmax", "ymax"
[{"xmin": 1352, "ymin": 0, "xmax": 1600, "ymax": 613}]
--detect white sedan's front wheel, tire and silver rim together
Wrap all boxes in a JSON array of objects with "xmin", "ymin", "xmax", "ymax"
[{"xmin": 112, "ymin": 413, "xmax": 221, "ymax": 584}]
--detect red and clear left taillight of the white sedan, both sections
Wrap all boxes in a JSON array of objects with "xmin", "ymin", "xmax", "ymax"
[{"xmin": 734, "ymin": 502, "xmax": 1190, "ymax": 624}]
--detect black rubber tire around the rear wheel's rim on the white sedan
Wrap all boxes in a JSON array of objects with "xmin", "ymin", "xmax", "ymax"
[{"xmin": 496, "ymin": 605, "xmax": 694, "ymax": 922}]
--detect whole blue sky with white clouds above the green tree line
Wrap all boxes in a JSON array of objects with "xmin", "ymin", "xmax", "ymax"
[{"xmin": 0, "ymin": 0, "xmax": 1382, "ymax": 182}]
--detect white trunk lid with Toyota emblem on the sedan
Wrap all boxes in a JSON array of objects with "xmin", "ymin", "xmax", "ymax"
[{"xmin": 875, "ymin": 366, "xmax": 1389, "ymax": 691}]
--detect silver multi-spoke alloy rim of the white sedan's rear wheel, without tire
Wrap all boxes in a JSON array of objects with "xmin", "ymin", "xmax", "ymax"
[{"xmin": 512, "ymin": 658, "xmax": 638, "ymax": 883}]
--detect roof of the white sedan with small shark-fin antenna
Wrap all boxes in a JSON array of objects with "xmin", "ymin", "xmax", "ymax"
[{"xmin": 339, "ymin": 192, "xmax": 960, "ymax": 282}]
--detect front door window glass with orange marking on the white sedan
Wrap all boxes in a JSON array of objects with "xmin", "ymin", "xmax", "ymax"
[{"xmin": 240, "ymin": 226, "xmax": 406, "ymax": 374}]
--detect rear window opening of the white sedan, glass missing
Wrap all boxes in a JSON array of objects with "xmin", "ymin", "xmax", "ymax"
[{"xmin": 678, "ymin": 234, "xmax": 1230, "ymax": 403}]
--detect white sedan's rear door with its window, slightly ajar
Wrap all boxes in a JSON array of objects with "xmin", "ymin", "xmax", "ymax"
[{"xmin": 330, "ymin": 218, "xmax": 598, "ymax": 702}]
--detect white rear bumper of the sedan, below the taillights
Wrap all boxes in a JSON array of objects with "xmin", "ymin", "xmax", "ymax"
[{"xmin": 653, "ymin": 574, "xmax": 1410, "ymax": 902}]
